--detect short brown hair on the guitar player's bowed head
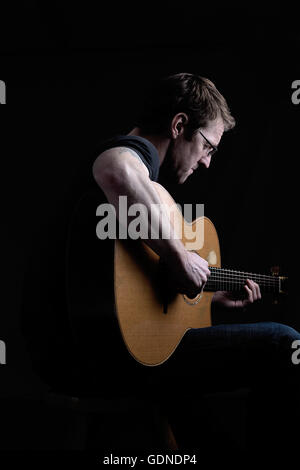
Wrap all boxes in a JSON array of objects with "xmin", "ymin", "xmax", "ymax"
[{"xmin": 135, "ymin": 73, "xmax": 235, "ymax": 140}]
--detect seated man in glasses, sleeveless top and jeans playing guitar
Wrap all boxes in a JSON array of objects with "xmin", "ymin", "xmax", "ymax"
[{"xmin": 88, "ymin": 73, "xmax": 300, "ymax": 452}]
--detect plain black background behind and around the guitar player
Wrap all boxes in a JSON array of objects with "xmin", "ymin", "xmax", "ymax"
[{"xmin": 0, "ymin": 1, "xmax": 300, "ymax": 456}]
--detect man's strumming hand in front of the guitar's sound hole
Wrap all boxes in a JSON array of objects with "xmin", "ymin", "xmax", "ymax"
[{"xmin": 167, "ymin": 250, "xmax": 210, "ymax": 298}]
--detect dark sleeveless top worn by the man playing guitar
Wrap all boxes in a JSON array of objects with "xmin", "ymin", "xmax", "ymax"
[{"xmin": 66, "ymin": 136, "xmax": 159, "ymax": 390}]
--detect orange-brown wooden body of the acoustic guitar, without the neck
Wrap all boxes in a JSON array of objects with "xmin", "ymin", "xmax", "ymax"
[{"xmin": 114, "ymin": 183, "xmax": 221, "ymax": 366}]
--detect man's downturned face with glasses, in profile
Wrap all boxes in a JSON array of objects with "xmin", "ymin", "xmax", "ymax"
[{"xmin": 170, "ymin": 118, "xmax": 224, "ymax": 184}]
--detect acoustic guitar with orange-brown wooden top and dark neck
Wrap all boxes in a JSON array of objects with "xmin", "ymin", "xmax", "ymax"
[{"xmin": 67, "ymin": 182, "xmax": 287, "ymax": 366}]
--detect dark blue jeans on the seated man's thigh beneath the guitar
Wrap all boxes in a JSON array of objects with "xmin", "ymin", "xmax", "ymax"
[{"xmin": 153, "ymin": 322, "xmax": 300, "ymax": 385}]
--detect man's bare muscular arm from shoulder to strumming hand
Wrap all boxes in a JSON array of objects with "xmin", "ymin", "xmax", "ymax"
[{"xmin": 93, "ymin": 147, "xmax": 209, "ymax": 296}]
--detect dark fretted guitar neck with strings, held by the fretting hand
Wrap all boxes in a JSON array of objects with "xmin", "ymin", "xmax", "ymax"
[{"xmin": 204, "ymin": 267, "xmax": 284, "ymax": 293}]
